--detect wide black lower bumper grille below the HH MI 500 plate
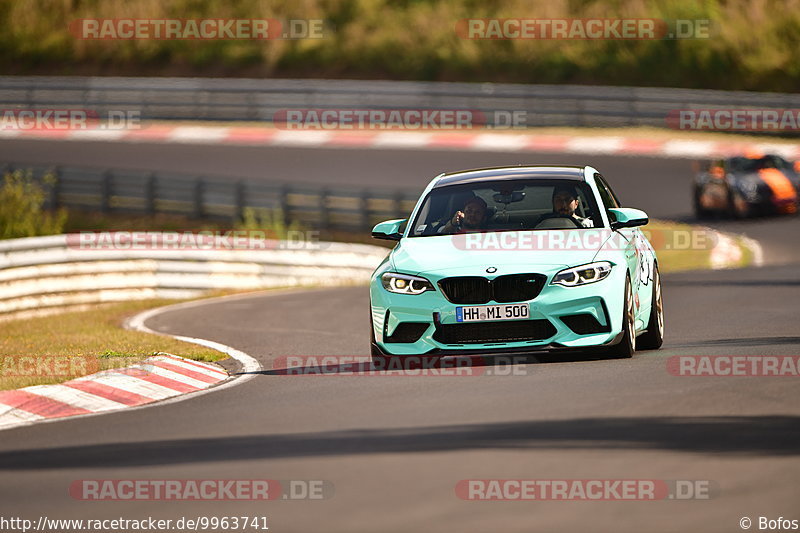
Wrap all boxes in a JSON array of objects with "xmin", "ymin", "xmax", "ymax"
[{"xmin": 433, "ymin": 320, "xmax": 556, "ymax": 344}]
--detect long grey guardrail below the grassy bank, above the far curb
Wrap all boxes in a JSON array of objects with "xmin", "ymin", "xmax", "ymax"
[{"xmin": 0, "ymin": 76, "xmax": 800, "ymax": 127}]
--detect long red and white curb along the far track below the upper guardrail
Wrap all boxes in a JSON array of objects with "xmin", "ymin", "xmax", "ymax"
[{"xmin": 0, "ymin": 124, "xmax": 800, "ymax": 160}]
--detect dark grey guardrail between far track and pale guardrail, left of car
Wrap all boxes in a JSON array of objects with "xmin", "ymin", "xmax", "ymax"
[{"xmin": 0, "ymin": 163, "xmax": 420, "ymax": 231}]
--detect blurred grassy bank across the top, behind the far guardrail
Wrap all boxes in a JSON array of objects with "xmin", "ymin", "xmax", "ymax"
[{"xmin": 0, "ymin": 0, "xmax": 800, "ymax": 92}]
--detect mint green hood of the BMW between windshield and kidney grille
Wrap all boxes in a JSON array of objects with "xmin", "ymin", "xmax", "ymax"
[{"xmin": 391, "ymin": 229, "xmax": 612, "ymax": 274}]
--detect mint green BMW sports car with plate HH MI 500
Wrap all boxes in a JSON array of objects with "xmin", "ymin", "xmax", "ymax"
[{"xmin": 370, "ymin": 166, "xmax": 664, "ymax": 362}]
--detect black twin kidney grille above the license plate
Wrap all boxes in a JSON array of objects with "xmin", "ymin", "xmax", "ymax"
[{"xmin": 439, "ymin": 274, "xmax": 547, "ymax": 305}]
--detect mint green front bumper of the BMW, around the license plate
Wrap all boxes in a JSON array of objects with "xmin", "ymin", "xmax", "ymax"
[{"xmin": 370, "ymin": 265, "xmax": 625, "ymax": 355}]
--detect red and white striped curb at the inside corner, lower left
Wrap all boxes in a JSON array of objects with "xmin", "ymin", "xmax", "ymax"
[{"xmin": 0, "ymin": 354, "xmax": 228, "ymax": 429}]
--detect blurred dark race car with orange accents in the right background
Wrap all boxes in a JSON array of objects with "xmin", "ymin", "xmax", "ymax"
[{"xmin": 693, "ymin": 154, "xmax": 800, "ymax": 218}]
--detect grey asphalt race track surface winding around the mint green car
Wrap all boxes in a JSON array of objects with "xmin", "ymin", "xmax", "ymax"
[{"xmin": 0, "ymin": 141, "xmax": 800, "ymax": 532}]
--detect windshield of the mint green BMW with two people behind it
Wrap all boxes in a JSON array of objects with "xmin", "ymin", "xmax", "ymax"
[{"xmin": 409, "ymin": 179, "xmax": 603, "ymax": 237}]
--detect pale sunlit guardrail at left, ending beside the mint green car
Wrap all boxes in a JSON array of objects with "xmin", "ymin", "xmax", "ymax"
[{"xmin": 0, "ymin": 235, "xmax": 388, "ymax": 314}]
